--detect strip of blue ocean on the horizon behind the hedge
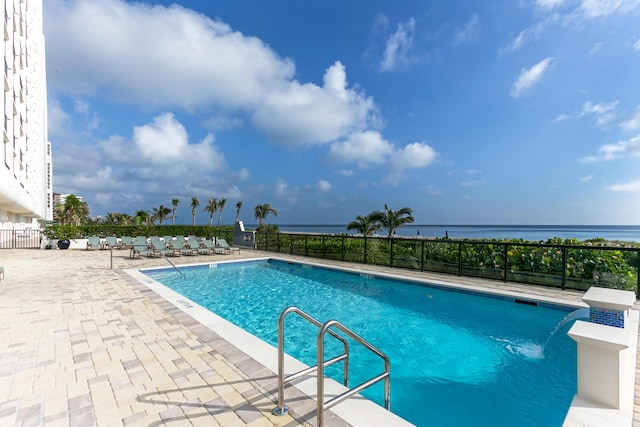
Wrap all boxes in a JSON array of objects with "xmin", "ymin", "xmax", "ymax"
[{"xmin": 247, "ymin": 224, "xmax": 640, "ymax": 243}]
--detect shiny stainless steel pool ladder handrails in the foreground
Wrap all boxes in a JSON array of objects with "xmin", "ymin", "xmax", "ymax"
[{"xmin": 272, "ymin": 306, "xmax": 391, "ymax": 427}]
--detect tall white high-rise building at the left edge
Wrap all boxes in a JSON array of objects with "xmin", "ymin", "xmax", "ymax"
[{"xmin": 0, "ymin": 0, "xmax": 53, "ymax": 230}]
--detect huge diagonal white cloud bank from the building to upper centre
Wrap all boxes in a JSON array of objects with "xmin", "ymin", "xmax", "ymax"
[{"xmin": 45, "ymin": 0, "xmax": 382, "ymax": 145}]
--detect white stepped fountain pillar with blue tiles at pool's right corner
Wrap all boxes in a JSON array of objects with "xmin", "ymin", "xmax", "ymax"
[{"xmin": 563, "ymin": 287, "xmax": 638, "ymax": 427}]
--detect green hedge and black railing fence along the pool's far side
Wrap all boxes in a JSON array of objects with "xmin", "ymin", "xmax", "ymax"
[{"xmin": 256, "ymin": 233, "xmax": 640, "ymax": 296}]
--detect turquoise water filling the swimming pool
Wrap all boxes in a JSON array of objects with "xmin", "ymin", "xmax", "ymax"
[{"xmin": 143, "ymin": 260, "xmax": 576, "ymax": 427}]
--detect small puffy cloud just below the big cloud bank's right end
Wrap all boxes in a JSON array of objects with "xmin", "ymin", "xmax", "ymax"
[{"xmin": 329, "ymin": 131, "xmax": 393, "ymax": 167}]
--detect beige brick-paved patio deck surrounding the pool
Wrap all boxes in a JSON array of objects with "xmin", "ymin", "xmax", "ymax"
[{"xmin": 0, "ymin": 250, "xmax": 640, "ymax": 427}]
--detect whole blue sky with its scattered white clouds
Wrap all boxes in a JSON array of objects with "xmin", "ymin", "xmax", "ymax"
[{"xmin": 44, "ymin": 0, "xmax": 640, "ymax": 224}]
